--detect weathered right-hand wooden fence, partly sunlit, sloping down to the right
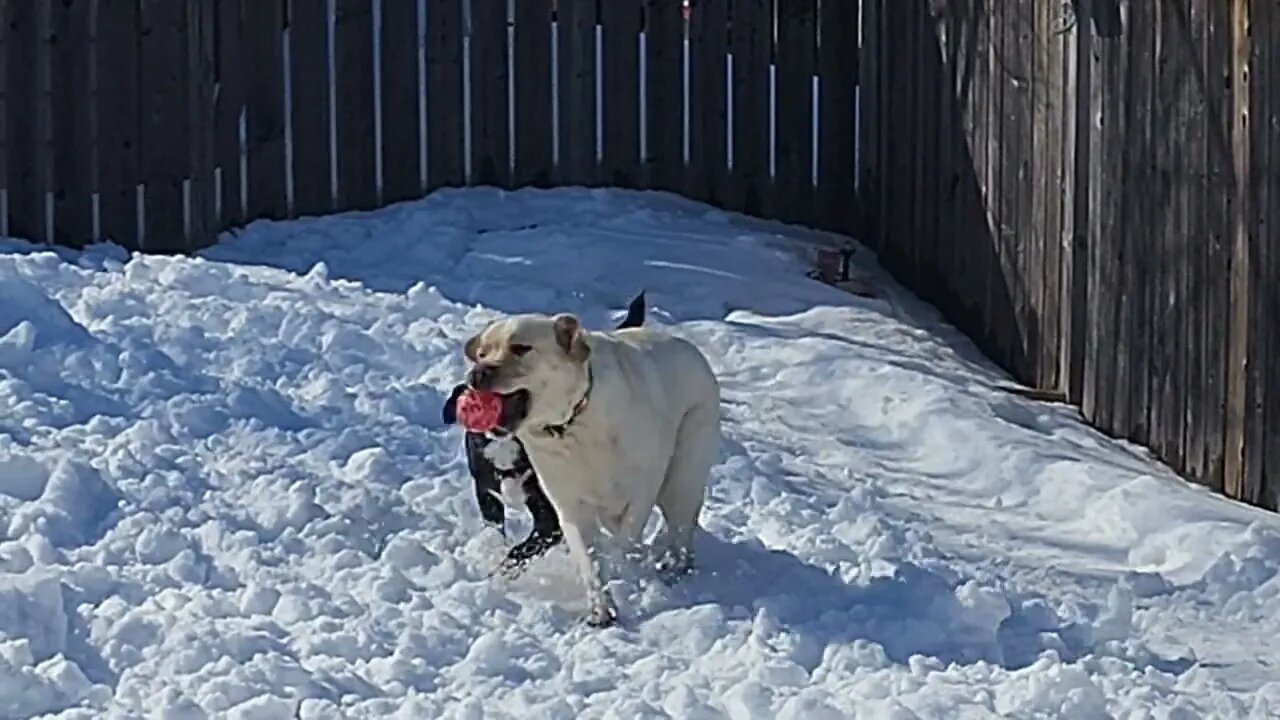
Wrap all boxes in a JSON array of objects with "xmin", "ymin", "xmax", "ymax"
[{"xmin": 860, "ymin": 0, "xmax": 1280, "ymax": 509}]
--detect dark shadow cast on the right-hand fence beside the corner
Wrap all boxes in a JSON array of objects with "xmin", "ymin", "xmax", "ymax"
[{"xmin": 873, "ymin": 0, "xmax": 1041, "ymax": 382}]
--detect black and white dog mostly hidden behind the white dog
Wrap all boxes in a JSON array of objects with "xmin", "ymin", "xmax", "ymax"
[{"xmin": 443, "ymin": 291, "xmax": 645, "ymax": 575}]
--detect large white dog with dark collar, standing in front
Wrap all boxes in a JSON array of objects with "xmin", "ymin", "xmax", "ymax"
[{"xmin": 465, "ymin": 314, "xmax": 721, "ymax": 626}]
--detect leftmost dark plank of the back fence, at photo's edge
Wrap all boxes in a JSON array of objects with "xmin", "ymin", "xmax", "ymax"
[{"xmin": 4, "ymin": 3, "xmax": 50, "ymax": 242}]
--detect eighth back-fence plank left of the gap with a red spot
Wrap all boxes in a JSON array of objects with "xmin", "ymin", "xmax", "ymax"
[{"xmin": 333, "ymin": 0, "xmax": 373, "ymax": 210}]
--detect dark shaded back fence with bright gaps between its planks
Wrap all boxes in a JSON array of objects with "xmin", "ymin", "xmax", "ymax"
[{"xmin": 0, "ymin": 0, "xmax": 859, "ymax": 252}]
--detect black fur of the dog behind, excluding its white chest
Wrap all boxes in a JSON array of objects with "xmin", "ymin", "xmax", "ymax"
[{"xmin": 443, "ymin": 291, "xmax": 645, "ymax": 569}]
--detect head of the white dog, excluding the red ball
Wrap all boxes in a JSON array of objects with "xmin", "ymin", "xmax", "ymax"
[{"xmin": 463, "ymin": 314, "xmax": 591, "ymax": 432}]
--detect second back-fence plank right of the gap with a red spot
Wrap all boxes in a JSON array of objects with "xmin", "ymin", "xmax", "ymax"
[{"xmin": 730, "ymin": 0, "xmax": 768, "ymax": 215}]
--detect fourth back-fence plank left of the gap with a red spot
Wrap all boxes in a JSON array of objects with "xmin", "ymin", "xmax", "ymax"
[{"xmin": 513, "ymin": 0, "xmax": 552, "ymax": 187}]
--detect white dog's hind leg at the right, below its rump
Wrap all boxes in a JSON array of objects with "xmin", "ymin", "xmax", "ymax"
[{"xmin": 654, "ymin": 402, "xmax": 721, "ymax": 577}]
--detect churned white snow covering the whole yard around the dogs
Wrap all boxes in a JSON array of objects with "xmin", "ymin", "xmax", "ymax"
[{"xmin": 0, "ymin": 190, "xmax": 1280, "ymax": 720}]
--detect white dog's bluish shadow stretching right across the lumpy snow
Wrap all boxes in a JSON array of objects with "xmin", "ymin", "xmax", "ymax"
[{"xmin": 588, "ymin": 533, "xmax": 1190, "ymax": 674}]
